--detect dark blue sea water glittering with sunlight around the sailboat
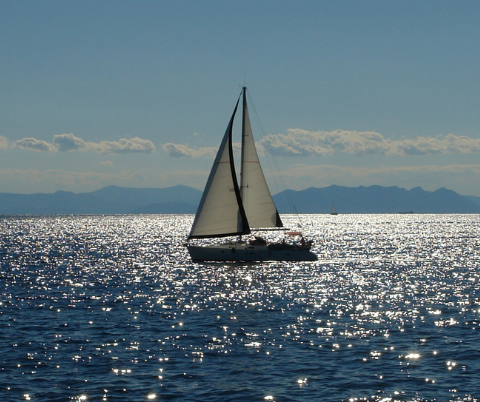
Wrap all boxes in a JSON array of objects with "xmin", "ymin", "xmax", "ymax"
[{"xmin": 0, "ymin": 215, "xmax": 480, "ymax": 402}]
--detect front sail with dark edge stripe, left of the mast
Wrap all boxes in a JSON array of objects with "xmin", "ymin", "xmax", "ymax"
[{"xmin": 188, "ymin": 98, "xmax": 250, "ymax": 238}]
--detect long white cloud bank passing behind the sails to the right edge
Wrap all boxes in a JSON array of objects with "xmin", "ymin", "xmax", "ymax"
[{"xmin": 162, "ymin": 129, "xmax": 480, "ymax": 158}]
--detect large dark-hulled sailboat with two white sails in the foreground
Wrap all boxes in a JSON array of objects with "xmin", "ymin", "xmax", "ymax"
[{"xmin": 186, "ymin": 87, "xmax": 317, "ymax": 262}]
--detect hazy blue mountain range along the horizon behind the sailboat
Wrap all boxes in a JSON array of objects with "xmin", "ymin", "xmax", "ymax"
[{"xmin": 0, "ymin": 186, "xmax": 480, "ymax": 215}]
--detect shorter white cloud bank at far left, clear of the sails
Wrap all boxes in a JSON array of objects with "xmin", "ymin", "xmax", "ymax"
[{"xmin": 11, "ymin": 134, "xmax": 155, "ymax": 154}]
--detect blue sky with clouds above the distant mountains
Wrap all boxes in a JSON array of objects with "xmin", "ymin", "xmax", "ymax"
[{"xmin": 0, "ymin": 0, "xmax": 480, "ymax": 196}]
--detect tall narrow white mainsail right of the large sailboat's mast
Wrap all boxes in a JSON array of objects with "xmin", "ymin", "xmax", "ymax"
[{"xmin": 240, "ymin": 88, "xmax": 283, "ymax": 228}]
